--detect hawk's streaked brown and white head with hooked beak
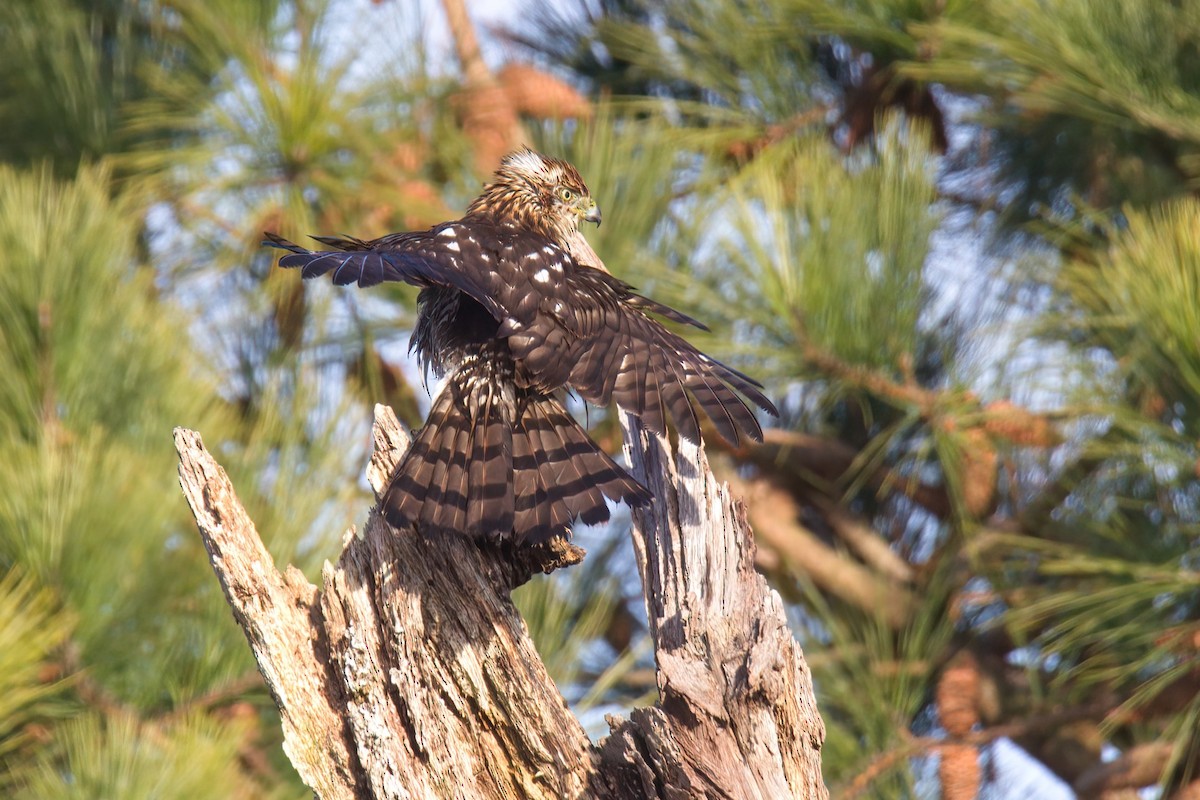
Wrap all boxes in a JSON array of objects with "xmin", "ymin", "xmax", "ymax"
[{"xmin": 467, "ymin": 148, "xmax": 600, "ymax": 246}]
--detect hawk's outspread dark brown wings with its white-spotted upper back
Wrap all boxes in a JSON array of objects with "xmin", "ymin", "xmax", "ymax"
[{"xmin": 264, "ymin": 225, "xmax": 778, "ymax": 444}]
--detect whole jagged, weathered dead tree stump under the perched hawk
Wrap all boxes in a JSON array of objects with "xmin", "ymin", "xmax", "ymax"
[{"xmin": 175, "ymin": 407, "xmax": 827, "ymax": 800}]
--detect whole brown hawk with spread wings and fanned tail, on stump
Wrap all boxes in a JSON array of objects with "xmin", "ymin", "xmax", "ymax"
[{"xmin": 264, "ymin": 149, "xmax": 775, "ymax": 543}]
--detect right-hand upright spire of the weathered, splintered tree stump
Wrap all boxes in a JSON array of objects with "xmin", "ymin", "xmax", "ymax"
[{"xmin": 595, "ymin": 414, "xmax": 828, "ymax": 800}]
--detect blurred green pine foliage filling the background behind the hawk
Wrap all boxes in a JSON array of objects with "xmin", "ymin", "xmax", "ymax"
[{"xmin": 0, "ymin": 0, "xmax": 1200, "ymax": 799}]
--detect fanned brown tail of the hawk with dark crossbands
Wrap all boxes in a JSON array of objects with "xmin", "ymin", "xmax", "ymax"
[{"xmin": 382, "ymin": 359, "xmax": 650, "ymax": 545}]
